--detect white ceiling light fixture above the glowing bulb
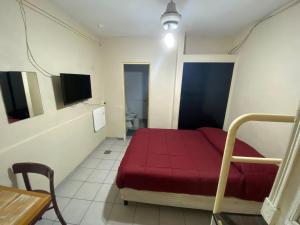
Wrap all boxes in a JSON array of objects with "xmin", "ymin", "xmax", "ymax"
[{"xmin": 160, "ymin": 0, "xmax": 181, "ymax": 30}]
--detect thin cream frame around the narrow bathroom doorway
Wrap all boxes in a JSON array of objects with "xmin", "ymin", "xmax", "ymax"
[{"xmin": 122, "ymin": 62, "xmax": 151, "ymax": 140}]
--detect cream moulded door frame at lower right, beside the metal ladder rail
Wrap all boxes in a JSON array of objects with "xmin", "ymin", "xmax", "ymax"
[{"xmin": 261, "ymin": 102, "xmax": 300, "ymax": 225}]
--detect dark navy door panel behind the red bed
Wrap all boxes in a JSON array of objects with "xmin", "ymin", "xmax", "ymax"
[{"xmin": 178, "ymin": 63, "xmax": 234, "ymax": 130}]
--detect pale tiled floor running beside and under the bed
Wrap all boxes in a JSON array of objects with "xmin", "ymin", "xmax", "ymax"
[{"xmin": 37, "ymin": 139, "xmax": 211, "ymax": 225}]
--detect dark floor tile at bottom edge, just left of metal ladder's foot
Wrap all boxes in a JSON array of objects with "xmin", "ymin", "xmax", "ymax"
[{"xmin": 184, "ymin": 209, "xmax": 211, "ymax": 225}]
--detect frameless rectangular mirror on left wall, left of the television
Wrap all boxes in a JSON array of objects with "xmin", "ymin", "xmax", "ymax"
[{"xmin": 0, "ymin": 71, "xmax": 44, "ymax": 123}]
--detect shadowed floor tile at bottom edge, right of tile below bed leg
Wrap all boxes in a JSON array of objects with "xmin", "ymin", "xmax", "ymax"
[{"xmin": 134, "ymin": 205, "xmax": 159, "ymax": 225}]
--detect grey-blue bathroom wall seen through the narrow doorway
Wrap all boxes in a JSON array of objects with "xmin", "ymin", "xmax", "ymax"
[{"xmin": 125, "ymin": 71, "xmax": 148, "ymax": 119}]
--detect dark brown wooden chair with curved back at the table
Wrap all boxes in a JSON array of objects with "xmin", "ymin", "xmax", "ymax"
[{"xmin": 12, "ymin": 163, "xmax": 67, "ymax": 225}]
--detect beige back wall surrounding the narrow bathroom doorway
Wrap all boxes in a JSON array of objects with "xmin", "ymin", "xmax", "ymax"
[{"xmin": 102, "ymin": 37, "xmax": 177, "ymax": 137}]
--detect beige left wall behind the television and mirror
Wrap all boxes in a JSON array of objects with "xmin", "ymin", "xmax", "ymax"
[{"xmin": 0, "ymin": 0, "xmax": 105, "ymax": 190}]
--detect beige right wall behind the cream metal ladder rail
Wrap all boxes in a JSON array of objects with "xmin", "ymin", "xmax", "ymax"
[{"xmin": 226, "ymin": 4, "xmax": 300, "ymax": 157}]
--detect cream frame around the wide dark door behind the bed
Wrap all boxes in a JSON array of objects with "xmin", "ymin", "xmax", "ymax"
[{"xmin": 172, "ymin": 54, "xmax": 237, "ymax": 129}]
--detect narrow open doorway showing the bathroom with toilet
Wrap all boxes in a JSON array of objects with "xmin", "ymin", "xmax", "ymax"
[{"xmin": 124, "ymin": 64, "xmax": 150, "ymax": 137}]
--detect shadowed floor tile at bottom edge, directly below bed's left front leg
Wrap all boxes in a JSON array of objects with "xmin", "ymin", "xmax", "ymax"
[{"xmin": 107, "ymin": 204, "xmax": 135, "ymax": 225}]
